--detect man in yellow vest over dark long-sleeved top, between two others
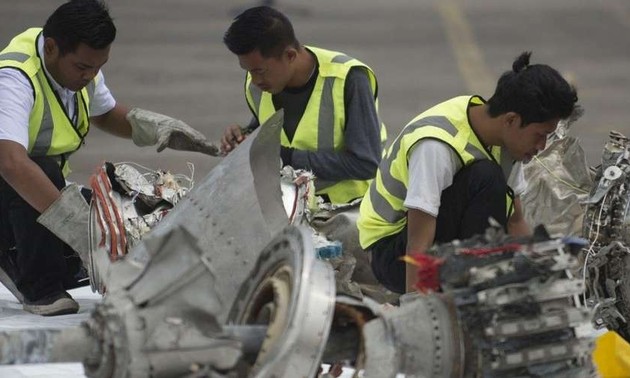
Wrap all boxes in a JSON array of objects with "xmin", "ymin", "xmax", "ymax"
[{"xmin": 221, "ymin": 6, "xmax": 386, "ymax": 203}]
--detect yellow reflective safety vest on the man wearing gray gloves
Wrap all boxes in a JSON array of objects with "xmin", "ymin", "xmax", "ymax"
[{"xmin": 0, "ymin": 28, "xmax": 96, "ymax": 176}]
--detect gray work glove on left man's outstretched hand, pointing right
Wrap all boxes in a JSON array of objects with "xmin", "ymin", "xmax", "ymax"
[{"xmin": 127, "ymin": 108, "xmax": 220, "ymax": 156}]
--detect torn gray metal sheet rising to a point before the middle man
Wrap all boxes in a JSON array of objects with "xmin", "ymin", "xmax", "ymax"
[{"xmin": 92, "ymin": 111, "xmax": 288, "ymax": 321}]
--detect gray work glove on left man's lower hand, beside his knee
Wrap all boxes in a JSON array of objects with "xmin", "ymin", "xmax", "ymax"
[{"xmin": 37, "ymin": 184, "xmax": 90, "ymax": 267}]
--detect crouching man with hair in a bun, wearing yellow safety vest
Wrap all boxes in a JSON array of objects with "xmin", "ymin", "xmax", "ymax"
[{"xmin": 358, "ymin": 53, "xmax": 577, "ymax": 293}]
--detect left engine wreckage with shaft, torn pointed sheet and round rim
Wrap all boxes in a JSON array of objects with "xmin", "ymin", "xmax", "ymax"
[{"xmin": 0, "ymin": 108, "xmax": 335, "ymax": 378}]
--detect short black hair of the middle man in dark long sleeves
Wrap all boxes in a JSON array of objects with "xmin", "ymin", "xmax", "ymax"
[{"xmin": 223, "ymin": 6, "xmax": 300, "ymax": 58}]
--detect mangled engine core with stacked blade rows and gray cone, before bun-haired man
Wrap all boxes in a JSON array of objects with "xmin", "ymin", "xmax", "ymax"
[{"xmin": 364, "ymin": 229, "xmax": 593, "ymax": 377}]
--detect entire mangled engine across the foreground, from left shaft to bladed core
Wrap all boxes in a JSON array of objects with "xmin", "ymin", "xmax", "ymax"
[{"xmin": 0, "ymin": 113, "xmax": 604, "ymax": 378}]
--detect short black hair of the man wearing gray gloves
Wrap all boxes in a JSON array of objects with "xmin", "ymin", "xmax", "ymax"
[{"xmin": 44, "ymin": 0, "xmax": 116, "ymax": 55}]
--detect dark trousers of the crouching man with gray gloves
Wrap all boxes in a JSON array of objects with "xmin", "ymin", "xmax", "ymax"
[{"xmin": 0, "ymin": 157, "xmax": 81, "ymax": 301}]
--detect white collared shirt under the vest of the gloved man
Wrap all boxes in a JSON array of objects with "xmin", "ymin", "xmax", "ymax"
[{"xmin": 0, "ymin": 34, "xmax": 116, "ymax": 149}]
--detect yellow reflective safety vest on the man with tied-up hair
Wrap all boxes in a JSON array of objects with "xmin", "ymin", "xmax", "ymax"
[{"xmin": 357, "ymin": 96, "xmax": 514, "ymax": 249}]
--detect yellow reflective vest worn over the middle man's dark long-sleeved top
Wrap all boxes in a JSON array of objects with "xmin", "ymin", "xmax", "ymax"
[{"xmin": 245, "ymin": 46, "xmax": 387, "ymax": 203}]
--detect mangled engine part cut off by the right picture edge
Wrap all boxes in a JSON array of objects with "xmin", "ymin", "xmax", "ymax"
[{"xmin": 583, "ymin": 131, "xmax": 630, "ymax": 341}]
